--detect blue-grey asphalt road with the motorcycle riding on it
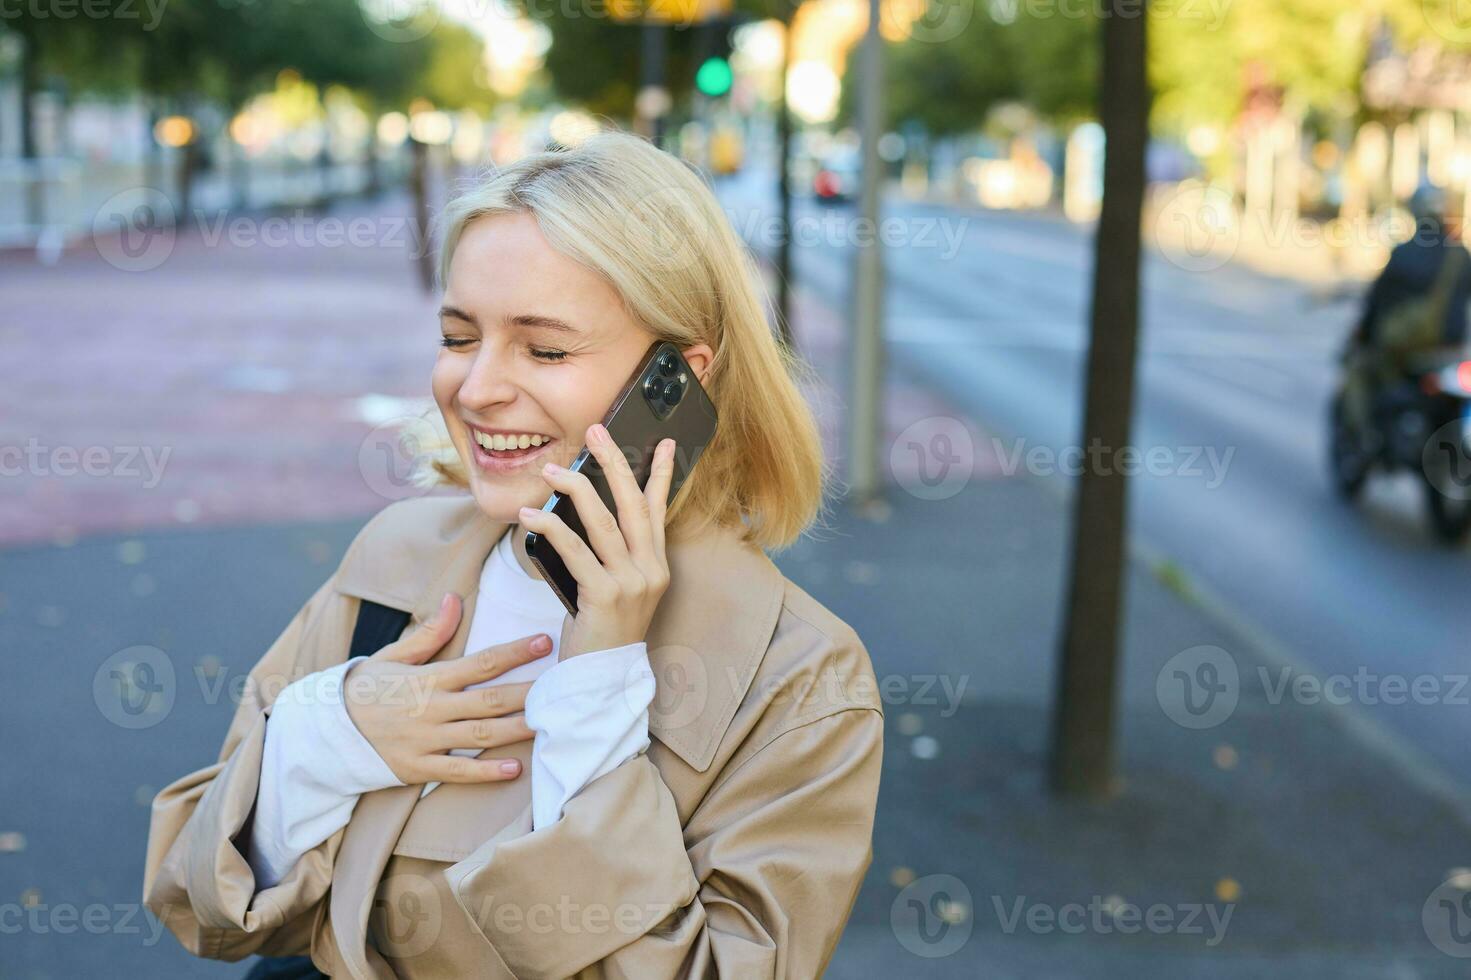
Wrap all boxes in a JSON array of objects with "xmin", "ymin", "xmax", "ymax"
[{"xmin": 727, "ymin": 169, "xmax": 1471, "ymax": 786}]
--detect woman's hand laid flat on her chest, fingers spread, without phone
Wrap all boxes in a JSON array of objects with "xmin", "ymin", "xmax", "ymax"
[{"xmin": 343, "ymin": 593, "xmax": 552, "ymax": 786}]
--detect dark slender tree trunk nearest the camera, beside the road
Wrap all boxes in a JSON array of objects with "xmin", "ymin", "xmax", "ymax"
[{"xmin": 1052, "ymin": 6, "xmax": 1150, "ymax": 799}]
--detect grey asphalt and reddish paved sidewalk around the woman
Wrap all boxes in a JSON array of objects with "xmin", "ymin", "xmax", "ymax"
[{"xmin": 0, "ymin": 194, "xmax": 1471, "ymax": 980}]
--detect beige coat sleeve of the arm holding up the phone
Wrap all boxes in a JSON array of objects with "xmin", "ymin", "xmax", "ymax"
[{"xmin": 446, "ymin": 697, "xmax": 883, "ymax": 980}]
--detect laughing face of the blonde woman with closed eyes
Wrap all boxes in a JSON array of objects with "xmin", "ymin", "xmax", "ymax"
[{"xmin": 434, "ymin": 213, "xmax": 710, "ymax": 524}]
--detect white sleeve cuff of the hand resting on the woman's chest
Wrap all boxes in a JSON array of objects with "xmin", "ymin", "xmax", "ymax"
[{"xmin": 246, "ymin": 658, "xmax": 403, "ymax": 890}]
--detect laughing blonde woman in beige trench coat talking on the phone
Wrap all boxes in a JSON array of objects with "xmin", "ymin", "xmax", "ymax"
[{"xmin": 144, "ymin": 132, "xmax": 883, "ymax": 979}]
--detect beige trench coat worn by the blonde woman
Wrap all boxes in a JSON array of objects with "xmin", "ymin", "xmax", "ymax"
[{"xmin": 144, "ymin": 496, "xmax": 883, "ymax": 980}]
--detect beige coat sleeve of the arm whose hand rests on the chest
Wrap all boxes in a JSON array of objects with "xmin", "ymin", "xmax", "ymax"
[{"xmin": 143, "ymin": 567, "xmax": 356, "ymax": 959}]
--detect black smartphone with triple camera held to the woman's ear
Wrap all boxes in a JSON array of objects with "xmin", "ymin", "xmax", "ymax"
[{"xmin": 525, "ymin": 341, "xmax": 718, "ymax": 615}]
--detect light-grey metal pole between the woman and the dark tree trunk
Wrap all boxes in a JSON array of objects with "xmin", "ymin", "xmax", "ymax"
[{"xmin": 849, "ymin": 0, "xmax": 884, "ymax": 505}]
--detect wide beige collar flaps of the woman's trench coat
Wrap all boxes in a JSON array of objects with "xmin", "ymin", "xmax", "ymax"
[{"xmin": 337, "ymin": 494, "xmax": 784, "ymax": 773}]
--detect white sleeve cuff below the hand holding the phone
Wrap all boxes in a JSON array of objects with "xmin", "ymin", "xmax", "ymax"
[{"xmin": 527, "ymin": 642, "xmax": 655, "ymax": 830}]
